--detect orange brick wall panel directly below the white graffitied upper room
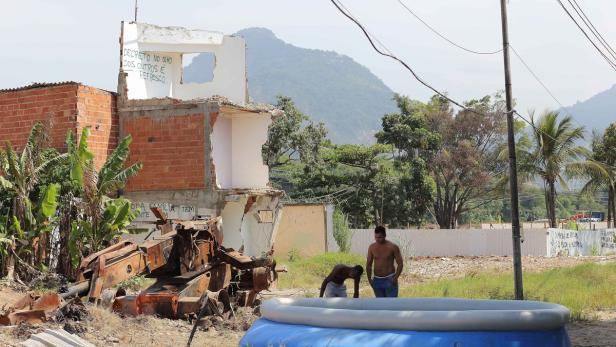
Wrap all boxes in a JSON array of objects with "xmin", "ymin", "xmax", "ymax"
[{"xmin": 121, "ymin": 111, "xmax": 205, "ymax": 192}]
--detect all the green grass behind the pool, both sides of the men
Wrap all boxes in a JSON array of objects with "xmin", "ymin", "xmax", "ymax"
[{"xmin": 278, "ymin": 253, "xmax": 616, "ymax": 320}]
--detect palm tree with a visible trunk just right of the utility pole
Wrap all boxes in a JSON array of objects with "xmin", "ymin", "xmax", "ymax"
[{"xmin": 521, "ymin": 111, "xmax": 588, "ymax": 228}]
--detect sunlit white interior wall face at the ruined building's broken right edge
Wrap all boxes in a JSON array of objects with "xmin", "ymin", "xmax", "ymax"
[{"xmin": 231, "ymin": 114, "xmax": 271, "ymax": 188}]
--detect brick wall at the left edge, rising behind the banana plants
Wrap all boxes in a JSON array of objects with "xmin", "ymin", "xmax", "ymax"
[{"xmin": 0, "ymin": 82, "xmax": 118, "ymax": 168}]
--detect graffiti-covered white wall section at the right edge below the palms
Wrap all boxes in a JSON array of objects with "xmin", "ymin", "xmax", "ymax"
[{"xmin": 547, "ymin": 229, "xmax": 616, "ymax": 257}]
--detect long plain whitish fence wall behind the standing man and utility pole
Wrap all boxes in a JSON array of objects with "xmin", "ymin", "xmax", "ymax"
[{"xmin": 351, "ymin": 229, "xmax": 547, "ymax": 256}]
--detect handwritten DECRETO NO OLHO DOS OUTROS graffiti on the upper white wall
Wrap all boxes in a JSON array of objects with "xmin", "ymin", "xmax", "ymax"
[{"xmin": 122, "ymin": 48, "xmax": 173, "ymax": 83}]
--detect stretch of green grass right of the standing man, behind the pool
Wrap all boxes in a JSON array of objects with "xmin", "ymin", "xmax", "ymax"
[{"xmin": 400, "ymin": 263, "xmax": 616, "ymax": 320}]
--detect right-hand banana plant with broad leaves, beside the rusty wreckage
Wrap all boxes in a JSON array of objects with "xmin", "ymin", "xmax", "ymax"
[{"xmin": 67, "ymin": 128, "xmax": 142, "ymax": 260}]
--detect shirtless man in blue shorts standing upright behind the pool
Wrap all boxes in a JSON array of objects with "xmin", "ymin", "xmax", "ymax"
[{"xmin": 366, "ymin": 226, "xmax": 403, "ymax": 298}]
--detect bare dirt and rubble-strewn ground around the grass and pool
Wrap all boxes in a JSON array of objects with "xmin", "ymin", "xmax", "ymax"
[{"xmin": 0, "ymin": 257, "xmax": 616, "ymax": 347}]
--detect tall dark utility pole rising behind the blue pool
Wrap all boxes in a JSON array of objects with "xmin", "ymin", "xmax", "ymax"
[{"xmin": 501, "ymin": 0, "xmax": 524, "ymax": 300}]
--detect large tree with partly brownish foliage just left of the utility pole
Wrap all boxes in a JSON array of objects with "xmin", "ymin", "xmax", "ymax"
[{"xmin": 377, "ymin": 95, "xmax": 505, "ymax": 229}]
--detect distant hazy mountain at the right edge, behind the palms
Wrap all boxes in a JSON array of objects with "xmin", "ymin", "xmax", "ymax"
[{"xmin": 563, "ymin": 84, "xmax": 616, "ymax": 137}]
